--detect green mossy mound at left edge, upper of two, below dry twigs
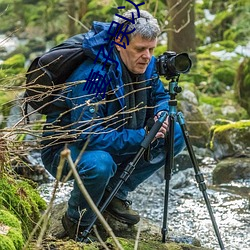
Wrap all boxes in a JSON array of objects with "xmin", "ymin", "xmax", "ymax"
[{"xmin": 0, "ymin": 174, "xmax": 46, "ymax": 238}]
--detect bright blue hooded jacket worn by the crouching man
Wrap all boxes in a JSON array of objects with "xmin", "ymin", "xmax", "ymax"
[{"xmin": 45, "ymin": 22, "xmax": 169, "ymax": 155}]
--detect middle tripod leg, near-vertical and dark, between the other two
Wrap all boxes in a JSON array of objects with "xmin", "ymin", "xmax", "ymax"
[{"xmin": 161, "ymin": 114, "xmax": 175, "ymax": 243}]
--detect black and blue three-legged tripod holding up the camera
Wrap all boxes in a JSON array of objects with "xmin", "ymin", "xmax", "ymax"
[{"xmin": 82, "ymin": 77, "xmax": 225, "ymax": 250}]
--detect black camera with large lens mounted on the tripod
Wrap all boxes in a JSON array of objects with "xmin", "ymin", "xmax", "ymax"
[{"xmin": 156, "ymin": 51, "xmax": 192, "ymax": 80}]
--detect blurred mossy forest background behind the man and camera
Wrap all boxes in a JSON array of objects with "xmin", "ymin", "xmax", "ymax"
[{"xmin": 0, "ymin": 0, "xmax": 250, "ymax": 127}]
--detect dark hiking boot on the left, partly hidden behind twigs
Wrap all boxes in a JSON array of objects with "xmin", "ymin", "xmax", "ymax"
[{"xmin": 62, "ymin": 213, "xmax": 97, "ymax": 243}]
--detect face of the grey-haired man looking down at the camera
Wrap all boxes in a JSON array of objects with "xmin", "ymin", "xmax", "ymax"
[{"xmin": 116, "ymin": 35, "xmax": 157, "ymax": 74}]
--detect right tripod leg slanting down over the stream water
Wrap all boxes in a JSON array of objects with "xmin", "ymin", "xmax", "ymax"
[{"xmin": 177, "ymin": 112, "xmax": 225, "ymax": 250}]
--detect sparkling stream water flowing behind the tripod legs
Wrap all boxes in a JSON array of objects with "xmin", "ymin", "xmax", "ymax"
[{"xmin": 39, "ymin": 157, "xmax": 250, "ymax": 250}]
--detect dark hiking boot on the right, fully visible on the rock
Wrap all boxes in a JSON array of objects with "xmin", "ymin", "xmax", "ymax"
[{"xmin": 105, "ymin": 197, "xmax": 140, "ymax": 225}]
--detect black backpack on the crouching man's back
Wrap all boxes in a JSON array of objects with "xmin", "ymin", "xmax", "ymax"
[{"xmin": 24, "ymin": 34, "xmax": 86, "ymax": 114}]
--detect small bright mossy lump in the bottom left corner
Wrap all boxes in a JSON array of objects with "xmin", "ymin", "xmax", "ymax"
[{"xmin": 0, "ymin": 209, "xmax": 24, "ymax": 250}]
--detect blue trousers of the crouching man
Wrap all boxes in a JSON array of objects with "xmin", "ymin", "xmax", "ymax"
[{"xmin": 42, "ymin": 123, "xmax": 185, "ymax": 226}]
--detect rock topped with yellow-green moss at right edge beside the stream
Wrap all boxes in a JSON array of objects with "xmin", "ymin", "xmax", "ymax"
[{"xmin": 209, "ymin": 120, "xmax": 250, "ymax": 159}]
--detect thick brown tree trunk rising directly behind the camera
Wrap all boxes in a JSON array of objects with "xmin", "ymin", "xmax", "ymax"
[{"xmin": 167, "ymin": 0, "xmax": 196, "ymax": 61}]
